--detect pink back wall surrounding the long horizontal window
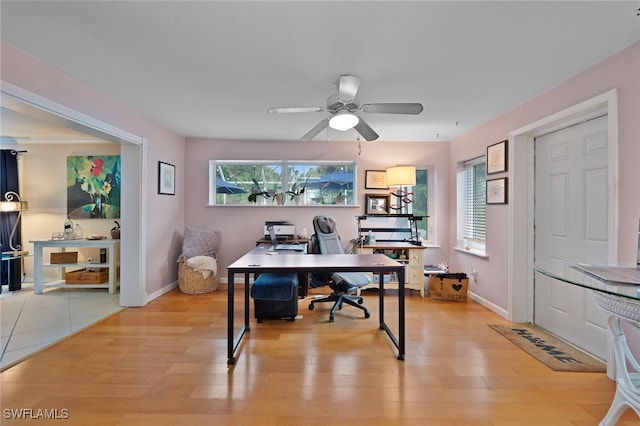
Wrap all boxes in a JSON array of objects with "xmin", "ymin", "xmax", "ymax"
[{"xmin": 185, "ymin": 139, "xmax": 451, "ymax": 279}]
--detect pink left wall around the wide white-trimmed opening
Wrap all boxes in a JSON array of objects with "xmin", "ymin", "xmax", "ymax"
[{"xmin": 1, "ymin": 42, "xmax": 185, "ymax": 293}]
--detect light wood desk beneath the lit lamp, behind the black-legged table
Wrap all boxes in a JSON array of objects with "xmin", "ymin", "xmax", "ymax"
[{"xmin": 356, "ymin": 241, "xmax": 425, "ymax": 297}]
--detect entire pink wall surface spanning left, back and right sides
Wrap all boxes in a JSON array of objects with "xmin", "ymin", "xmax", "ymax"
[{"xmin": 1, "ymin": 36, "xmax": 640, "ymax": 308}]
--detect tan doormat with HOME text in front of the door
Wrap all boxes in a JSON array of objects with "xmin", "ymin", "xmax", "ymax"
[{"xmin": 488, "ymin": 324, "xmax": 607, "ymax": 373}]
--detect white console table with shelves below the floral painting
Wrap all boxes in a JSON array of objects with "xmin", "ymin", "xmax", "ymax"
[{"xmin": 29, "ymin": 239, "xmax": 120, "ymax": 294}]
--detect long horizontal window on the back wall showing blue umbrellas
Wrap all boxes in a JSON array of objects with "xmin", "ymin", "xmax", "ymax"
[{"xmin": 209, "ymin": 160, "xmax": 357, "ymax": 206}]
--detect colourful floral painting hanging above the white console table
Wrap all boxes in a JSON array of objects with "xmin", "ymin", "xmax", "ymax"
[{"xmin": 67, "ymin": 155, "xmax": 121, "ymax": 219}]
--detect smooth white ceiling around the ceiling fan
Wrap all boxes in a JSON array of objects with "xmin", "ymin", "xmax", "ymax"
[{"xmin": 0, "ymin": 0, "xmax": 640, "ymax": 141}]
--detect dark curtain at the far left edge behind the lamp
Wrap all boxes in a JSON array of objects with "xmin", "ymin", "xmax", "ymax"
[{"xmin": 0, "ymin": 149, "xmax": 22, "ymax": 285}]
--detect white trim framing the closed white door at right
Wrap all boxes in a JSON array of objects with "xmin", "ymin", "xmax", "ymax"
[{"xmin": 507, "ymin": 89, "xmax": 618, "ymax": 323}]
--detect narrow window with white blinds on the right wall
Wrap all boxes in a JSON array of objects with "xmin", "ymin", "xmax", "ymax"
[{"xmin": 458, "ymin": 155, "xmax": 486, "ymax": 253}]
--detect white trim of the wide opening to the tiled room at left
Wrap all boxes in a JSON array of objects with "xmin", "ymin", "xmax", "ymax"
[{"xmin": 0, "ymin": 81, "xmax": 148, "ymax": 306}]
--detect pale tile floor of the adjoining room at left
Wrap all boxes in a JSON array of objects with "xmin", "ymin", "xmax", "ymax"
[{"xmin": 0, "ymin": 283, "xmax": 121, "ymax": 370}]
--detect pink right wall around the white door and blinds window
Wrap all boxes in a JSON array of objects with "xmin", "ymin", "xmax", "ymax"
[{"xmin": 450, "ymin": 42, "xmax": 640, "ymax": 309}]
